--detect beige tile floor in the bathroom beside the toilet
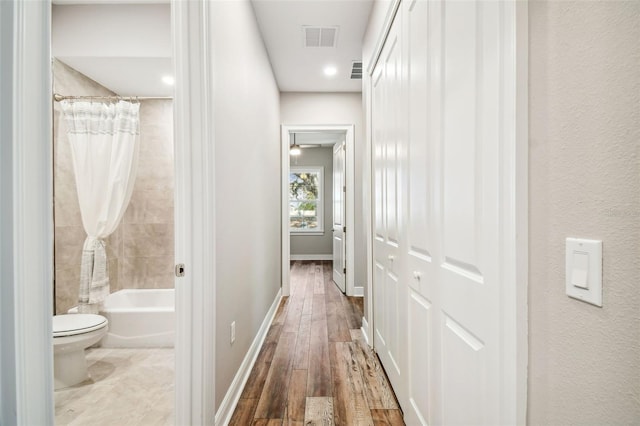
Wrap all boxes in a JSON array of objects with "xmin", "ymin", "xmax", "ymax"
[{"xmin": 54, "ymin": 348, "xmax": 175, "ymax": 426}]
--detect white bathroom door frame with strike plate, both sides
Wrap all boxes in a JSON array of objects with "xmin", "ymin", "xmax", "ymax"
[{"xmin": 0, "ymin": 0, "xmax": 216, "ymax": 425}]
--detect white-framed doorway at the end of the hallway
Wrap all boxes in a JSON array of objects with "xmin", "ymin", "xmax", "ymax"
[{"xmin": 281, "ymin": 125, "xmax": 355, "ymax": 296}]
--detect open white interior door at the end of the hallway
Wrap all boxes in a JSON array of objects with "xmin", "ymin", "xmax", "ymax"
[{"xmin": 333, "ymin": 141, "xmax": 347, "ymax": 293}]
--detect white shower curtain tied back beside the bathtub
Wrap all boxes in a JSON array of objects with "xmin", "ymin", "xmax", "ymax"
[{"xmin": 61, "ymin": 101, "xmax": 140, "ymax": 313}]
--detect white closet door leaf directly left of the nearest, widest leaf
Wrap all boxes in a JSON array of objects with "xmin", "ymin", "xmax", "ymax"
[{"xmin": 402, "ymin": 0, "xmax": 440, "ymax": 425}]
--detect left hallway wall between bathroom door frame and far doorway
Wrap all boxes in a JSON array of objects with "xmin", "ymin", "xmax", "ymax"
[{"xmin": 211, "ymin": 1, "xmax": 281, "ymax": 409}]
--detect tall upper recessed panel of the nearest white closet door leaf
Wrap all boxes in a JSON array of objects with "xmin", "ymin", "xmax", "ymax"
[{"xmin": 443, "ymin": 0, "xmax": 483, "ymax": 272}]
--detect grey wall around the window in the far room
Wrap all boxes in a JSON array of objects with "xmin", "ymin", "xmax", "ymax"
[{"xmin": 289, "ymin": 148, "xmax": 333, "ymax": 255}]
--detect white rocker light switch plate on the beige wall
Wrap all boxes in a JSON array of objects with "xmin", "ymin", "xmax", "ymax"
[{"xmin": 565, "ymin": 238, "xmax": 602, "ymax": 306}]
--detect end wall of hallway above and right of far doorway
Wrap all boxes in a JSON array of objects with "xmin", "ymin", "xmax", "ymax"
[{"xmin": 280, "ymin": 92, "xmax": 367, "ymax": 287}]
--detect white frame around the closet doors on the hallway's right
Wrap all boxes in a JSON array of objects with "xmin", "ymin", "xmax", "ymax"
[{"xmin": 363, "ymin": 0, "xmax": 529, "ymax": 424}]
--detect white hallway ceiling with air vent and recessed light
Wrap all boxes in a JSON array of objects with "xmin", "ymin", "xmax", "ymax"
[{"xmin": 252, "ymin": 0, "xmax": 373, "ymax": 92}]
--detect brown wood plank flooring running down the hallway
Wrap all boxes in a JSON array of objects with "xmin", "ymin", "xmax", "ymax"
[{"xmin": 230, "ymin": 261, "xmax": 404, "ymax": 426}]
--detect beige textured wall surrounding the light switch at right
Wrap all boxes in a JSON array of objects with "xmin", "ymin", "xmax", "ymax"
[{"xmin": 528, "ymin": 1, "xmax": 640, "ymax": 425}]
